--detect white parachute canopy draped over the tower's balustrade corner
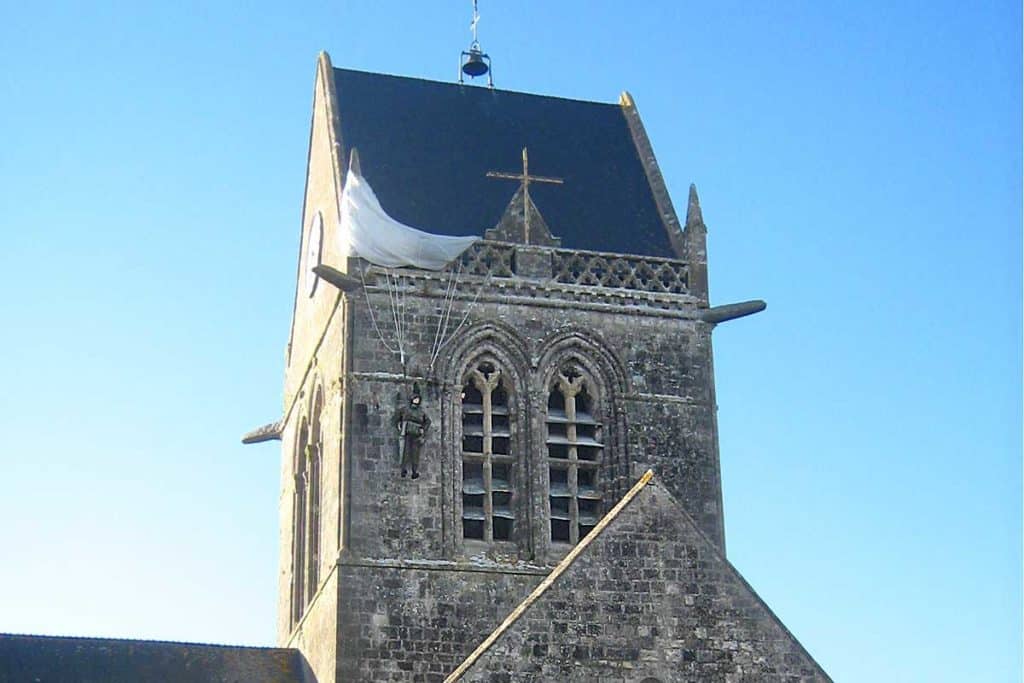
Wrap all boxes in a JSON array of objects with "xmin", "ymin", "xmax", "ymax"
[{"xmin": 338, "ymin": 168, "xmax": 480, "ymax": 270}]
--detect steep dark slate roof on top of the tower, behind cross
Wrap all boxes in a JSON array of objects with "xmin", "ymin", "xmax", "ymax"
[{"xmin": 334, "ymin": 69, "xmax": 676, "ymax": 257}]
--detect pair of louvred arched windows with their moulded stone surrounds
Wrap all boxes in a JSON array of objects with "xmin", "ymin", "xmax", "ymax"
[{"xmin": 447, "ymin": 323, "xmax": 626, "ymax": 557}]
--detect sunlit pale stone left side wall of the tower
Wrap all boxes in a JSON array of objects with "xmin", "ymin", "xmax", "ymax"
[{"xmin": 276, "ymin": 55, "xmax": 347, "ymax": 683}]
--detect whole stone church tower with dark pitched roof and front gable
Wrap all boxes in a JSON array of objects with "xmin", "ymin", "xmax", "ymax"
[{"xmin": 241, "ymin": 53, "xmax": 828, "ymax": 683}]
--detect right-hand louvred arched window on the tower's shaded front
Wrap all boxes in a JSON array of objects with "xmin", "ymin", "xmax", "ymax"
[{"xmin": 546, "ymin": 368, "xmax": 604, "ymax": 545}]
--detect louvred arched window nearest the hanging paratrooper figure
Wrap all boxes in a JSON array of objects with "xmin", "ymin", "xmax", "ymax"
[{"xmin": 462, "ymin": 361, "xmax": 516, "ymax": 543}]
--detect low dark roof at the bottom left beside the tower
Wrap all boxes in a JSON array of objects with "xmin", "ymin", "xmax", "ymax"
[{"xmin": 0, "ymin": 634, "xmax": 303, "ymax": 683}]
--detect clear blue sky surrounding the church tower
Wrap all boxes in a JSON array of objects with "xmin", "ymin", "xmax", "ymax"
[{"xmin": 0, "ymin": 0, "xmax": 1022, "ymax": 681}]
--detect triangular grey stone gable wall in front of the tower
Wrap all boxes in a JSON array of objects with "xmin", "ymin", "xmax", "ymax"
[{"xmin": 462, "ymin": 480, "xmax": 830, "ymax": 683}]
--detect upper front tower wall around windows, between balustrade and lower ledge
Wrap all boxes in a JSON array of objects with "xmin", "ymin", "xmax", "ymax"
[{"xmin": 347, "ymin": 264, "xmax": 723, "ymax": 565}]
